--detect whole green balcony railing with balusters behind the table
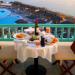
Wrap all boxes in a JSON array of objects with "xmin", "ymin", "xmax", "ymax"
[{"xmin": 0, "ymin": 24, "xmax": 75, "ymax": 42}]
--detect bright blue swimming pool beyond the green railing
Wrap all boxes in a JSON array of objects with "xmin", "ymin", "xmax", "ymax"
[{"xmin": 0, "ymin": 8, "xmax": 23, "ymax": 24}]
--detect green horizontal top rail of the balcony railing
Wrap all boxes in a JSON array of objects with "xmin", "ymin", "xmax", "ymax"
[{"xmin": 0, "ymin": 24, "xmax": 75, "ymax": 27}]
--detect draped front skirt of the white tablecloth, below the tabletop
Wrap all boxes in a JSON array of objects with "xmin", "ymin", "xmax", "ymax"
[{"xmin": 15, "ymin": 41, "xmax": 58, "ymax": 62}]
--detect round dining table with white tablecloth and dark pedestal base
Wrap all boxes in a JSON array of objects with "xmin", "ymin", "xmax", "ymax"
[{"xmin": 14, "ymin": 27, "xmax": 58, "ymax": 75}]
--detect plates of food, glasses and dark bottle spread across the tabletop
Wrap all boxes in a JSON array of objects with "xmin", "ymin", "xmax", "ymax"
[{"xmin": 13, "ymin": 27, "xmax": 58, "ymax": 48}]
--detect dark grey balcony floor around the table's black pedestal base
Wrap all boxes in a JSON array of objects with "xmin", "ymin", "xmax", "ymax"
[{"xmin": 0, "ymin": 58, "xmax": 60, "ymax": 75}]
